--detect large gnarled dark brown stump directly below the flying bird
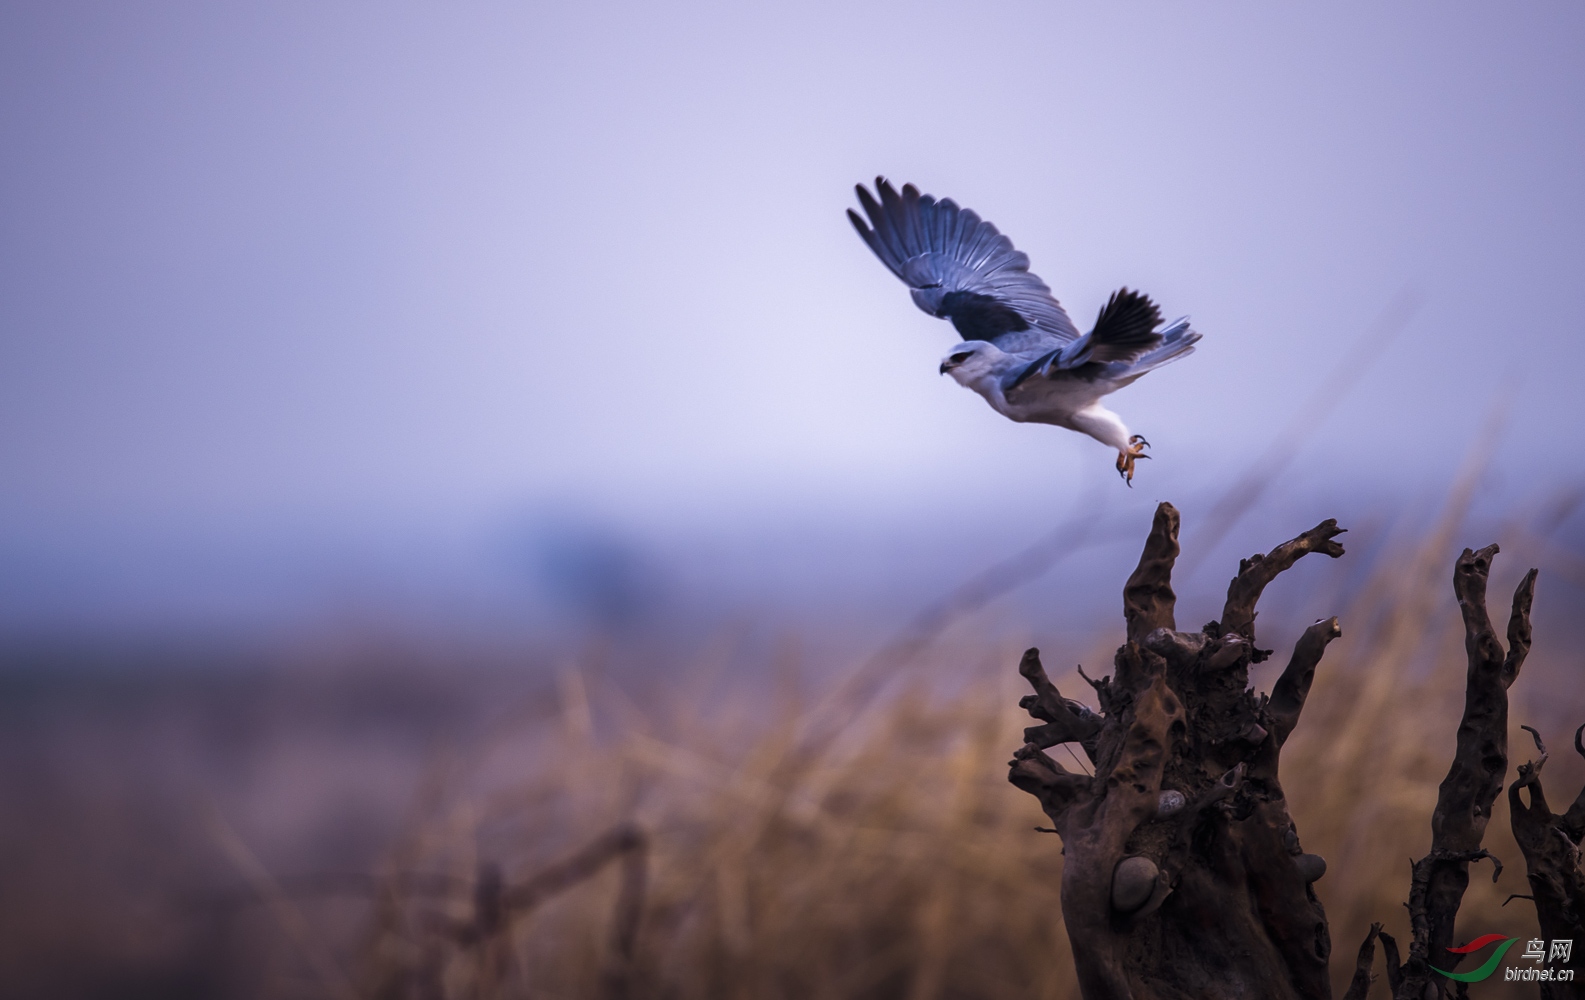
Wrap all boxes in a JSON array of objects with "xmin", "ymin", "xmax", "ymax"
[{"xmin": 1010, "ymin": 504, "xmax": 1337, "ymax": 1000}]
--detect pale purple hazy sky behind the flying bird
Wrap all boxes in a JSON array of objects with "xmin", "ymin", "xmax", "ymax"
[{"xmin": 0, "ymin": 2, "xmax": 1585, "ymax": 633}]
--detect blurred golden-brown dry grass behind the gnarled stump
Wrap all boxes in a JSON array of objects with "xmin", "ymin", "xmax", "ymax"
[{"xmin": 219, "ymin": 490, "xmax": 1585, "ymax": 1000}]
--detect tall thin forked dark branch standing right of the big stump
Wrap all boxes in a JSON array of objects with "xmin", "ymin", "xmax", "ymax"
[{"xmin": 1349, "ymin": 545, "xmax": 1536, "ymax": 1000}]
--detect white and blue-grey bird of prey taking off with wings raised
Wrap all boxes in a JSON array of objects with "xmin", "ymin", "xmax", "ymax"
[{"xmin": 848, "ymin": 177, "xmax": 1200, "ymax": 487}]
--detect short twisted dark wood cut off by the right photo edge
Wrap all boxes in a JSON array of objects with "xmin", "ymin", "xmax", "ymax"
[{"xmin": 1507, "ymin": 726, "xmax": 1585, "ymax": 1000}]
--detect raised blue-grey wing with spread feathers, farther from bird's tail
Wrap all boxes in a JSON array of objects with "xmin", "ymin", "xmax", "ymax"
[{"xmin": 848, "ymin": 177, "xmax": 1079, "ymax": 357}]
